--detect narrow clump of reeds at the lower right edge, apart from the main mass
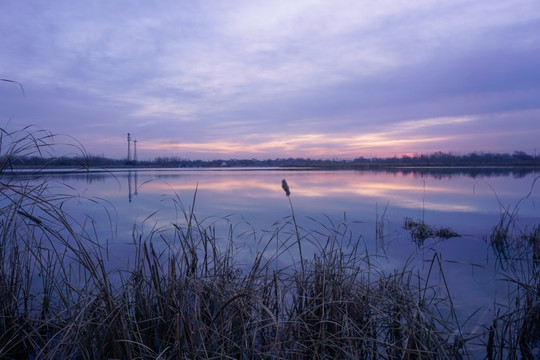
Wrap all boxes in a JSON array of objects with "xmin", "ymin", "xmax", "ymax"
[{"xmin": 486, "ymin": 222, "xmax": 540, "ymax": 360}]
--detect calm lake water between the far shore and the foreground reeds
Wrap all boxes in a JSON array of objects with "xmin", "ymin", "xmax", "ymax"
[{"xmin": 11, "ymin": 169, "xmax": 540, "ymax": 338}]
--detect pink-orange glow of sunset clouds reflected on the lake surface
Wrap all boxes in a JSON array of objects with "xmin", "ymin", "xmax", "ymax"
[{"xmin": 125, "ymin": 170, "xmax": 477, "ymax": 211}]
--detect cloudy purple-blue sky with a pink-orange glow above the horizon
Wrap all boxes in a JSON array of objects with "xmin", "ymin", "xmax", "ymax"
[{"xmin": 0, "ymin": 0, "xmax": 540, "ymax": 160}]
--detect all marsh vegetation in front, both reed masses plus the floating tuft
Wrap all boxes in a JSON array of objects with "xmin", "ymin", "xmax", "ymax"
[{"xmin": 0, "ymin": 126, "xmax": 540, "ymax": 359}]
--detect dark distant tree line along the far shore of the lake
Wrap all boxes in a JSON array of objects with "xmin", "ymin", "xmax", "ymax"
[{"xmin": 5, "ymin": 151, "xmax": 540, "ymax": 168}]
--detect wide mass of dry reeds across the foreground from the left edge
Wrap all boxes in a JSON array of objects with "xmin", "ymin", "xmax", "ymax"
[{"xmin": 0, "ymin": 163, "xmax": 464, "ymax": 359}]
